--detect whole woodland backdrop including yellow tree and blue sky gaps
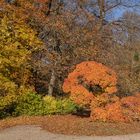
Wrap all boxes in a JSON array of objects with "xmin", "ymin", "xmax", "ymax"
[{"xmin": 0, "ymin": 0, "xmax": 140, "ymax": 119}]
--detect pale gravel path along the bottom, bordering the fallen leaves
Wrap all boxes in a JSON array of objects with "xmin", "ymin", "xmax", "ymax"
[{"xmin": 0, "ymin": 125, "xmax": 140, "ymax": 140}]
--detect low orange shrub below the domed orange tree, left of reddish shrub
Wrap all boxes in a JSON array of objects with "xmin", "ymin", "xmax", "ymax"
[{"xmin": 90, "ymin": 96, "xmax": 127, "ymax": 122}]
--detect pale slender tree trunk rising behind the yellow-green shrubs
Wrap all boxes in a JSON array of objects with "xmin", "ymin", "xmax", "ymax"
[{"xmin": 48, "ymin": 69, "xmax": 56, "ymax": 96}]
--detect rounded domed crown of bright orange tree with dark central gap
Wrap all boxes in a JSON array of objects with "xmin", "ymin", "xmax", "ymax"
[{"xmin": 63, "ymin": 61, "xmax": 117, "ymax": 106}]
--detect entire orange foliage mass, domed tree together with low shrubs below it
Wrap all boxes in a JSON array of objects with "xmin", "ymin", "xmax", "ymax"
[{"xmin": 63, "ymin": 61, "xmax": 140, "ymax": 122}]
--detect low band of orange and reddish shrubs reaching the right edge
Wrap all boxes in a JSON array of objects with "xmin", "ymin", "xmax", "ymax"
[{"xmin": 91, "ymin": 93, "xmax": 140, "ymax": 122}]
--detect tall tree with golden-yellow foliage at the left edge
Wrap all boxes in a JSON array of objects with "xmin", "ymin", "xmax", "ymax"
[{"xmin": 0, "ymin": 5, "xmax": 42, "ymax": 111}]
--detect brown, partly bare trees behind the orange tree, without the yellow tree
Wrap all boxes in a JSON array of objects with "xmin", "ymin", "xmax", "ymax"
[{"xmin": 0, "ymin": 0, "xmax": 140, "ymax": 99}]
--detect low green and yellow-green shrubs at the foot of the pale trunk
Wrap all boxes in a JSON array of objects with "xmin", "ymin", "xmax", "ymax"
[{"xmin": 13, "ymin": 93, "xmax": 77, "ymax": 116}]
